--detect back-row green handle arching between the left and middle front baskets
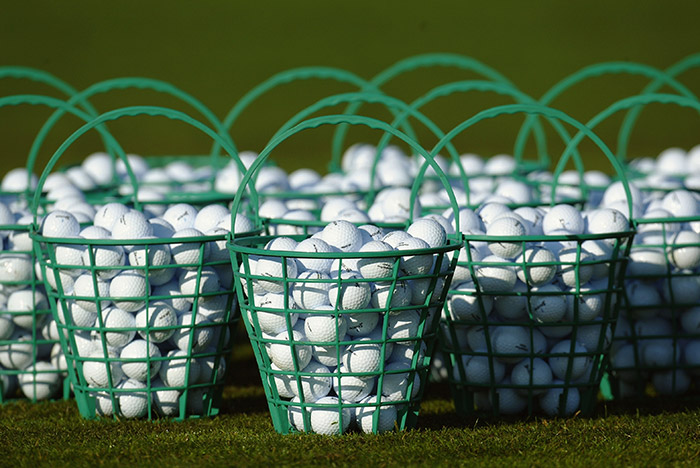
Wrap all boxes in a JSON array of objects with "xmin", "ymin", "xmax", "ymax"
[{"xmin": 211, "ymin": 67, "xmax": 373, "ymax": 161}]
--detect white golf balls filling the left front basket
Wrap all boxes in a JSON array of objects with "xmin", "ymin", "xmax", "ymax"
[{"xmin": 34, "ymin": 200, "xmax": 253, "ymax": 418}]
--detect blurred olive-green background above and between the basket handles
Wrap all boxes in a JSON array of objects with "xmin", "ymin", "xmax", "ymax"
[{"xmin": 0, "ymin": 0, "xmax": 700, "ymax": 176}]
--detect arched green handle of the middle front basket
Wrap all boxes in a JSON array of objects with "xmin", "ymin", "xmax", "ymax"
[{"xmin": 231, "ymin": 114, "xmax": 461, "ymax": 240}]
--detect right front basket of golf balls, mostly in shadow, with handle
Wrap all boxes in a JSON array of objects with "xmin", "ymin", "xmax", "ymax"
[{"xmin": 440, "ymin": 104, "xmax": 634, "ymax": 417}]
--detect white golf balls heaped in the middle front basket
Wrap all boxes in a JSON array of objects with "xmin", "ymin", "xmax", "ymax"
[{"xmin": 238, "ymin": 218, "xmax": 459, "ymax": 435}]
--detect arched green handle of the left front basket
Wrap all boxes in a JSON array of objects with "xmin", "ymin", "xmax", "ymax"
[{"xmin": 32, "ymin": 106, "xmax": 252, "ymax": 225}]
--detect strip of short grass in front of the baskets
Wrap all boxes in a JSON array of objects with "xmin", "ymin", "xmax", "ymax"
[{"xmin": 0, "ymin": 330, "xmax": 700, "ymax": 467}]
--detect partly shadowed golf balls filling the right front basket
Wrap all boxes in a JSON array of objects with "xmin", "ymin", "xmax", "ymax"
[{"xmin": 442, "ymin": 202, "xmax": 630, "ymax": 416}]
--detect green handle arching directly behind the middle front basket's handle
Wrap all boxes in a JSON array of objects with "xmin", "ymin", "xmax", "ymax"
[{"xmin": 271, "ymin": 92, "xmax": 459, "ymax": 204}]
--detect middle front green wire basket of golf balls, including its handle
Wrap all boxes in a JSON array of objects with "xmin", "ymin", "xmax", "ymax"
[{"xmin": 229, "ymin": 115, "xmax": 461, "ymax": 434}]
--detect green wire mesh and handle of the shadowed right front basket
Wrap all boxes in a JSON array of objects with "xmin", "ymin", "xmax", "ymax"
[{"xmin": 431, "ymin": 104, "xmax": 635, "ymax": 416}]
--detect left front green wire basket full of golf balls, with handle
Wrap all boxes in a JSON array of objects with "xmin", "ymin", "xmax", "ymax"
[{"xmin": 31, "ymin": 106, "xmax": 254, "ymax": 420}]
